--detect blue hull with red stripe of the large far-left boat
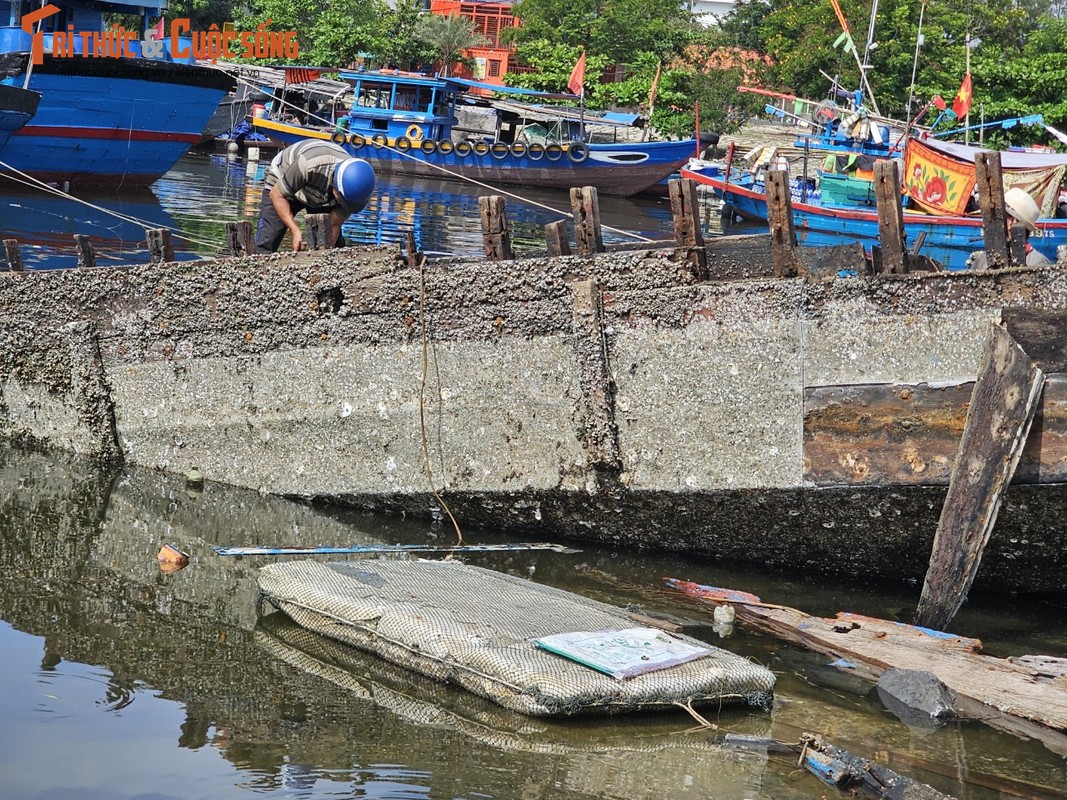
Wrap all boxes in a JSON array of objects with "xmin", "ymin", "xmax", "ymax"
[{"xmin": 0, "ymin": 55, "xmax": 233, "ymax": 188}]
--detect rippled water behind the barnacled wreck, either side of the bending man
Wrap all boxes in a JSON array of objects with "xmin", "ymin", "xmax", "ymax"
[{"xmin": 0, "ymin": 147, "xmax": 673, "ymax": 268}]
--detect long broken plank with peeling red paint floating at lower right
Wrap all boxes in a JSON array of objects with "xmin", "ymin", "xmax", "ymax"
[{"xmin": 667, "ymin": 578, "xmax": 1067, "ymax": 754}]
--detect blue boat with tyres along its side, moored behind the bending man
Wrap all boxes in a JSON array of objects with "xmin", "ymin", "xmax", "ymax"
[{"xmin": 254, "ymin": 71, "xmax": 697, "ymax": 196}]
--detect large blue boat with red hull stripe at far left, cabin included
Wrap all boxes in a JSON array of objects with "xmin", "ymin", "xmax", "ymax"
[{"xmin": 0, "ymin": 0, "xmax": 234, "ymax": 188}]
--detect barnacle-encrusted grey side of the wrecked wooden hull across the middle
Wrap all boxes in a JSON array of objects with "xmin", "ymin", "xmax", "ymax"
[{"xmin": 0, "ymin": 249, "xmax": 1067, "ymax": 591}]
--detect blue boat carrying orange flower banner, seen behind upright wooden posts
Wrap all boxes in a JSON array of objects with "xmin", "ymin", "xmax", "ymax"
[{"xmin": 681, "ymin": 133, "xmax": 1067, "ymax": 270}]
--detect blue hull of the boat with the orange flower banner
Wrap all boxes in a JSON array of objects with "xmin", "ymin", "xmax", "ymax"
[{"xmin": 682, "ymin": 170, "xmax": 1067, "ymax": 270}]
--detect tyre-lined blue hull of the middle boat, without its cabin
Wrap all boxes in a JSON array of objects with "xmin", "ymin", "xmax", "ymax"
[{"xmin": 255, "ymin": 119, "xmax": 696, "ymax": 196}]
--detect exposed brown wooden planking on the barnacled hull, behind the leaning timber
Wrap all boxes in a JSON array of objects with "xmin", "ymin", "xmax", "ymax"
[{"xmin": 803, "ymin": 374, "xmax": 1067, "ymax": 486}]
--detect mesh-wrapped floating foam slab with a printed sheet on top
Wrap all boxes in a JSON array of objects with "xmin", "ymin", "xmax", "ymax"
[{"xmin": 259, "ymin": 560, "xmax": 775, "ymax": 716}]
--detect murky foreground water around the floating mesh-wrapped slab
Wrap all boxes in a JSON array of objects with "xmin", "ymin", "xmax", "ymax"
[{"xmin": 0, "ymin": 450, "xmax": 1067, "ymax": 800}]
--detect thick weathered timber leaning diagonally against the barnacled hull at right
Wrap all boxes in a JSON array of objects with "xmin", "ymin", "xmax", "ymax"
[{"xmin": 915, "ymin": 324, "xmax": 1045, "ymax": 630}]
